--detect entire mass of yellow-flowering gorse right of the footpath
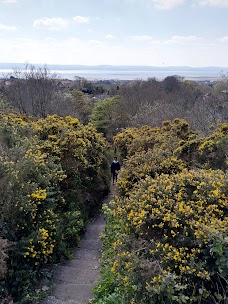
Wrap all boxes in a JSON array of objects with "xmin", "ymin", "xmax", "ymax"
[{"xmin": 94, "ymin": 119, "xmax": 228, "ymax": 304}]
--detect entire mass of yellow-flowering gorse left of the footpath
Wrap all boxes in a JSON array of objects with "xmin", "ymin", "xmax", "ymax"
[{"xmin": 0, "ymin": 113, "xmax": 109, "ymax": 302}]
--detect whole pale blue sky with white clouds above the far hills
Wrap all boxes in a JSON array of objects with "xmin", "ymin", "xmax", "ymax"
[{"xmin": 0, "ymin": 0, "xmax": 228, "ymax": 67}]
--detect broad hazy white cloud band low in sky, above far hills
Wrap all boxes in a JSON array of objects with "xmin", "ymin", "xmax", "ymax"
[{"xmin": 0, "ymin": 37, "xmax": 227, "ymax": 66}]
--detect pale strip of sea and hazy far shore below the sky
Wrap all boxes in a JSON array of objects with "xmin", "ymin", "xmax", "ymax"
[{"xmin": 0, "ymin": 63, "xmax": 228, "ymax": 81}]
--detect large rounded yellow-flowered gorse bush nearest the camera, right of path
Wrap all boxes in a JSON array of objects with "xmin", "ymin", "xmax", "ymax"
[{"xmin": 96, "ymin": 170, "xmax": 228, "ymax": 303}]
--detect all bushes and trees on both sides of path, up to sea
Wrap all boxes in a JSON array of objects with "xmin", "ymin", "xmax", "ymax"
[{"xmin": 0, "ymin": 66, "xmax": 228, "ymax": 304}]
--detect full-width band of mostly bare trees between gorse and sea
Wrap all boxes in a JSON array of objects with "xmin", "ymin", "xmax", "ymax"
[{"xmin": 2, "ymin": 65, "xmax": 228, "ymax": 138}]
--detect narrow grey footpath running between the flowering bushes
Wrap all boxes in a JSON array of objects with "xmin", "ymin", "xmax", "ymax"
[{"xmin": 40, "ymin": 186, "xmax": 115, "ymax": 304}]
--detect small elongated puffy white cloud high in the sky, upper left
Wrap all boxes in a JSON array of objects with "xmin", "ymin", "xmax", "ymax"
[{"xmin": 33, "ymin": 17, "xmax": 68, "ymax": 31}]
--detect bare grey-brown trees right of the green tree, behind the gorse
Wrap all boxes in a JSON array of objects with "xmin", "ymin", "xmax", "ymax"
[{"xmin": 102, "ymin": 76, "xmax": 228, "ymax": 134}]
